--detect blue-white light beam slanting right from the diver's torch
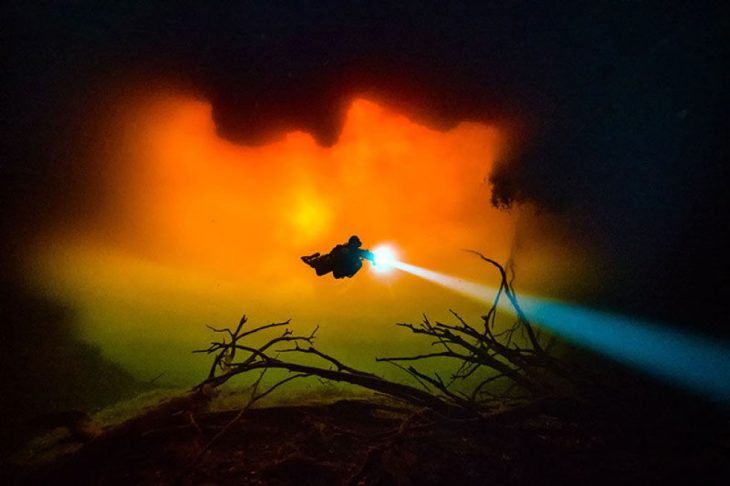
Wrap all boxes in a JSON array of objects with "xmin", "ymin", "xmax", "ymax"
[{"xmin": 390, "ymin": 260, "xmax": 730, "ymax": 408}]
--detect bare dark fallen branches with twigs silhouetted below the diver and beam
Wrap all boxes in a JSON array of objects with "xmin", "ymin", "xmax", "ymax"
[{"xmin": 194, "ymin": 254, "xmax": 578, "ymax": 417}]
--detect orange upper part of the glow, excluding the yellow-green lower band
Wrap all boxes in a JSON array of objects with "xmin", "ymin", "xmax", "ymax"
[{"xmin": 88, "ymin": 97, "xmax": 511, "ymax": 284}]
